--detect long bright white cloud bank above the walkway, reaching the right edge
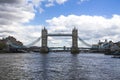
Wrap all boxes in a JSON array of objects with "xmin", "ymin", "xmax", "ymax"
[{"xmin": 46, "ymin": 15, "xmax": 120, "ymax": 46}]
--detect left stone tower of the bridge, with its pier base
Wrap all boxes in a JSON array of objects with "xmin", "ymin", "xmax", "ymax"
[{"xmin": 40, "ymin": 28, "xmax": 49, "ymax": 53}]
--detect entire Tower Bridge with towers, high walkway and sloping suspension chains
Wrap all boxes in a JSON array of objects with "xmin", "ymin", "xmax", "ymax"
[{"xmin": 8, "ymin": 28, "xmax": 91, "ymax": 53}]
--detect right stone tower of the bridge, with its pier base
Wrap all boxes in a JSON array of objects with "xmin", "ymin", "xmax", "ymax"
[{"xmin": 71, "ymin": 28, "xmax": 79, "ymax": 53}]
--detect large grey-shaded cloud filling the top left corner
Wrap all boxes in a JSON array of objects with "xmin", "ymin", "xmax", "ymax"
[{"xmin": 0, "ymin": 0, "xmax": 35, "ymax": 25}]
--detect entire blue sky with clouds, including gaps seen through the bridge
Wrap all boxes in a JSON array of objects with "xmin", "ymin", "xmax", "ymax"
[{"xmin": 0, "ymin": 0, "xmax": 120, "ymax": 46}]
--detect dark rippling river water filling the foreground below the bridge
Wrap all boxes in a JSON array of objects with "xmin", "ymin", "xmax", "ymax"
[{"xmin": 0, "ymin": 52, "xmax": 120, "ymax": 80}]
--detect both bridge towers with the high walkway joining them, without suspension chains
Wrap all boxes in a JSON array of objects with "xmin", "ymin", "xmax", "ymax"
[{"xmin": 40, "ymin": 28, "xmax": 79, "ymax": 53}]
